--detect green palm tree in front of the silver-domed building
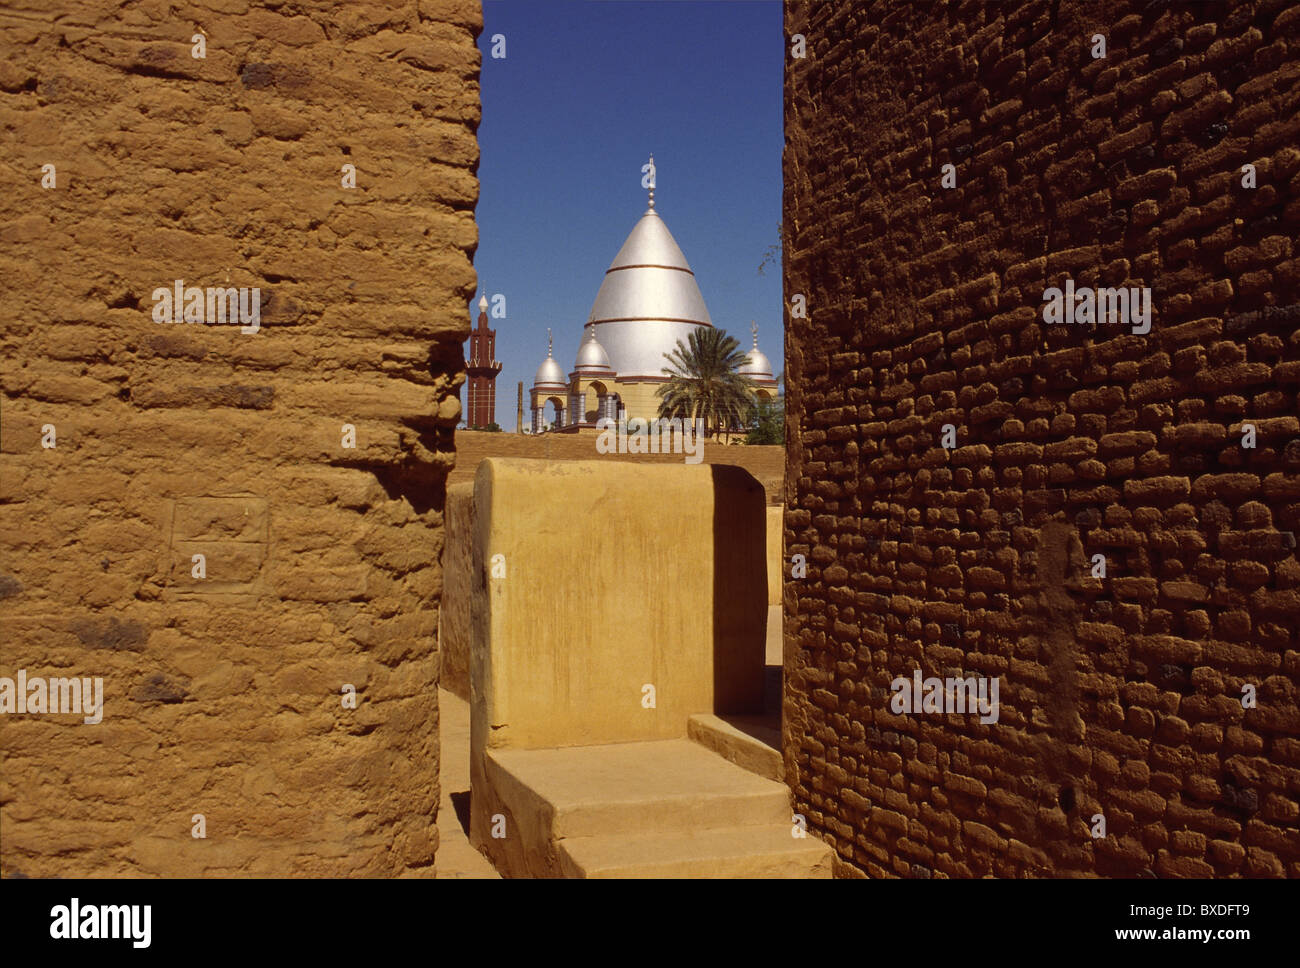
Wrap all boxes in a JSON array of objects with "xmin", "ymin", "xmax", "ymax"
[{"xmin": 655, "ymin": 326, "xmax": 755, "ymax": 435}]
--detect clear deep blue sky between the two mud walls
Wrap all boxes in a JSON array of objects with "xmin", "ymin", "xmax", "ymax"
[{"xmin": 475, "ymin": 0, "xmax": 784, "ymax": 430}]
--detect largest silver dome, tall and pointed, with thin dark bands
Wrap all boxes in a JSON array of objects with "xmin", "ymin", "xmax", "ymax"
[{"xmin": 588, "ymin": 208, "xmax": 712, "ymax": 379}]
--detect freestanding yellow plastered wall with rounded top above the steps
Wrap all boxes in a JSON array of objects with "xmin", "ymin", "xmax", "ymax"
[{"xmin": 469, "ymin": 457, "xmax": 768, "ymax": 756}]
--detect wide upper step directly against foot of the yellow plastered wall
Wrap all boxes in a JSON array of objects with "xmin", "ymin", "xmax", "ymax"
[{"xmin": 486, "ymin": 739, "xmax": 793, "ymax": 841}]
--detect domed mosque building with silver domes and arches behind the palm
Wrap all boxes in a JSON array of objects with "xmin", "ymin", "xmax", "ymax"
[{"xmin": 529, "ymin": 157, "xmax": 777, "ymax": 434}]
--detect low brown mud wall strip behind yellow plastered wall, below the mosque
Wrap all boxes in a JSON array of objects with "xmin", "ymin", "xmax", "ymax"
[{"xmin": 447, "ymin": 430, "xmax": 785, "ymax": 504}]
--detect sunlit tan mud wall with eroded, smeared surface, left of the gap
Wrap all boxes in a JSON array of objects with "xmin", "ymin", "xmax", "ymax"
[{"xmin": 0, "ymin": 0, "xmax": 482, "ymax": 876}]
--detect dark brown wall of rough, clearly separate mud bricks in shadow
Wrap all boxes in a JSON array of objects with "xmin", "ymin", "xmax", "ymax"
[{"xmin": 784, "ymin": 0, "xmax": 1300, "ymax": 877}]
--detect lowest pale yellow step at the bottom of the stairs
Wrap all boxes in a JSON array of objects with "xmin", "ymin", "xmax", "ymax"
[{"xmin": 559, "ymin": 824, "xmax": 831, "ymax": 878}]
